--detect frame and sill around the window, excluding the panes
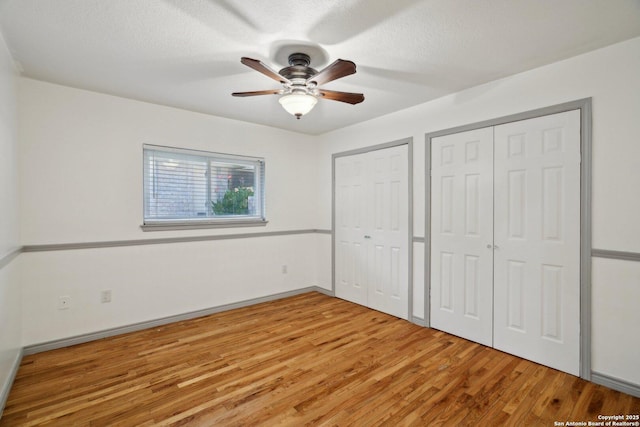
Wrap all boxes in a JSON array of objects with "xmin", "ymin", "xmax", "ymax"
[{"xmin": 140, "ymin": 144, "xmax": 268, "ymax": 231}]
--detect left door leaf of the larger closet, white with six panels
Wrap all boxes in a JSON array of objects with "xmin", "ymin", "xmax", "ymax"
[{"xmin": 430, "ymin": 128, "xmax": 493, "ymax": 346}]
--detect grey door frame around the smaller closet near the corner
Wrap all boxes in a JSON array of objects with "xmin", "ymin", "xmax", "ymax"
[{"xmin": 331, "ymin": 137, "xmax": 413, "ymax": 322}]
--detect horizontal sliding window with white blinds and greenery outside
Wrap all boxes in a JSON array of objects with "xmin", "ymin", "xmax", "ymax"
[{"xmin": 142, "ymin": 144, "xmax": 266, "ymax": 230}]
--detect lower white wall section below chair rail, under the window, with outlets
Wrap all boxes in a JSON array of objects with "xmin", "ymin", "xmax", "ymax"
[{"xmin": 22, "ymin": 235, "xmax": 315, "ymax": 345}]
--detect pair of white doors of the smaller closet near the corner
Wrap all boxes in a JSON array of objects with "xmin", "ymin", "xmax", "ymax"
[{"xmin": 334, "ymin": 145, "xmax": 409, "ymax": 319}]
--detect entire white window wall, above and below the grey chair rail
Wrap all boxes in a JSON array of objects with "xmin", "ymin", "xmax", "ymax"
[{"xmin": 18, "ymin": 78, "xmax": 317, "ymax": 345}]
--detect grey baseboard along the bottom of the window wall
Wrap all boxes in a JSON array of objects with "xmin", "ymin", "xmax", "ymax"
[{"xmin": 23, "ymin": 286, "xmax": 333, "ymax": 355}]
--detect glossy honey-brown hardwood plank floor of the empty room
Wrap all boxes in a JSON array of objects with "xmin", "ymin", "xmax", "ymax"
[{"xmin": 0, "ymin": 293, "xmax": 640, "ymax": 426}]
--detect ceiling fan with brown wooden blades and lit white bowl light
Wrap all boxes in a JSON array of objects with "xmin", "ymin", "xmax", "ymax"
[{"xmin": 231, "ymin": 53, "xmax": 364, "ymax": 119}]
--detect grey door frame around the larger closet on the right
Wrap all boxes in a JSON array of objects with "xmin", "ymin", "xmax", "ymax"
[{"xmin": 424, "ymin": 98, "xmax": 592, "ymax": 380}]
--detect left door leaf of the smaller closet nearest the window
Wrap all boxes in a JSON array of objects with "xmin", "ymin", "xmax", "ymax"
[{"xmin": 334, "ymin": 154, "xmax": 369, "ymax": 305}]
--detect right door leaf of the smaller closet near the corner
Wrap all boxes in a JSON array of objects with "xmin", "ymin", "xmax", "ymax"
[{"xmin": 367, "ymin": 145, "xmax": 409, "ymax": 319}]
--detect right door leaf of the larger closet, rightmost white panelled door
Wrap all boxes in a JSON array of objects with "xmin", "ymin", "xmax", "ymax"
[{"xmin": 494, "ymin": 110, "xmax": 580, "ymax": 375}]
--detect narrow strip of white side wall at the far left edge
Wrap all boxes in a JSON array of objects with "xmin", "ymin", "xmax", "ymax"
[{"xmin": 0, "ymin": 34, "xmax": 21, "ymax": 402}]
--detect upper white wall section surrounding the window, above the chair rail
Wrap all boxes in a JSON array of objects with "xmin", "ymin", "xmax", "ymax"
[{"xmin": 18, "ymin": 78, "xmax": 316, "ymax": 245}]
